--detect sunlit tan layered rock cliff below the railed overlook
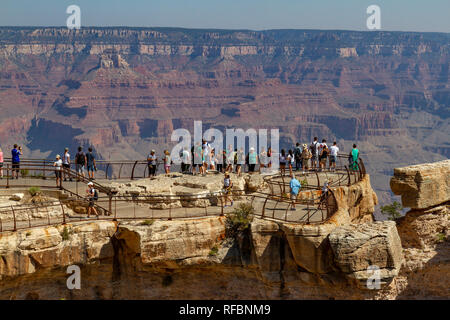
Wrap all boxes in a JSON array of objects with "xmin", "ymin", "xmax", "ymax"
[{"xmin": 0, "ymin": 163, "xmax": 450, "ymax": 299}]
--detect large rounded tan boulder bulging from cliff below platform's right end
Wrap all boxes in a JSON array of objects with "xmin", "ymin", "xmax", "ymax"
[{"xmin": 329, "ymin": 221, "xmax": 403, "ymax": 285}]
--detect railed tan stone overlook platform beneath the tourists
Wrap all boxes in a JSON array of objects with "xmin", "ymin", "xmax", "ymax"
[{"xmin": 0, "ymin": 155, "xmax": 366, "ymax": 232}]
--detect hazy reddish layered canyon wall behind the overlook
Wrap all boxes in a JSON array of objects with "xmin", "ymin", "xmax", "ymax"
[{"xmin": 0, "ymin": 27, "xmax": 450, "ymax": 208}]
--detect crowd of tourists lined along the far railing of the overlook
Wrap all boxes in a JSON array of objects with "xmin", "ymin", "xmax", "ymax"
[{"xmin": 147, "ymin": 137, "xmax": 359, "ymax": 177}]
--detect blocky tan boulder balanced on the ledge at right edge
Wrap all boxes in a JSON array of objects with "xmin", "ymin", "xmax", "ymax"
[{"xmin": 390, "ymin": 160, "xmax": 450, "ymax": 209}]
